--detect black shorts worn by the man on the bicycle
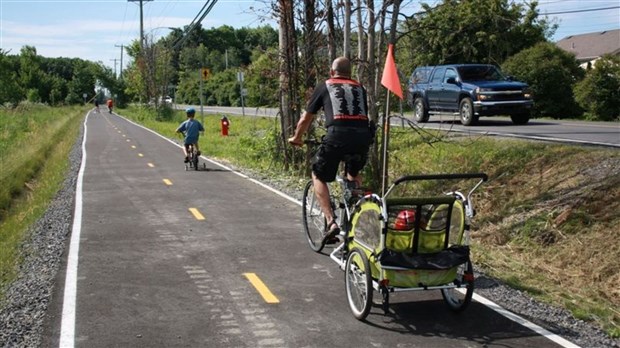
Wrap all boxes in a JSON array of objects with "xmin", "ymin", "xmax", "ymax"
[{"xmin": 312, "ymin": 127, "xmax": 371, "ymax": 182}]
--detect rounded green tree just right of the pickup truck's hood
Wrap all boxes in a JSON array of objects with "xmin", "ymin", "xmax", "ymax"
[{"xmin": 502, "ymin": 42, "xmax": 583, "ymax": 119}]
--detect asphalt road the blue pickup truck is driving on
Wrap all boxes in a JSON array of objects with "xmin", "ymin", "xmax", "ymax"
[{"xmin": 186, "ymin": 106, "xmax": 620, "ymax": 148}]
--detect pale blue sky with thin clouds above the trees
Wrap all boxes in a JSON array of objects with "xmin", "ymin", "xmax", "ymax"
[{"xmin": 0, "ymin": 0, "xmax": 620, "ymax": 71}]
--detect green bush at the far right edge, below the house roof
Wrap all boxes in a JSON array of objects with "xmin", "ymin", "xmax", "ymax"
[{"xmin": 575, "ymin": 54, "xmax": 620, "ymax": 121}]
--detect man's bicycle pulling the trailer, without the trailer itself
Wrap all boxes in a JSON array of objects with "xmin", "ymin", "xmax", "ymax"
[{"xmin": 302, "ymin": 140, "xmax": 364, "ymax": 253}]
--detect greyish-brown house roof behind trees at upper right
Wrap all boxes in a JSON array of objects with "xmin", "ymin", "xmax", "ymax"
[{"xmin": 556, "ymin": 29, "xmax": 620, "ymax": 61}]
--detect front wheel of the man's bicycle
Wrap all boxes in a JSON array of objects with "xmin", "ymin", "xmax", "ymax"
[{"xmin": 301, "ymin": 180, "xmax": 327, "ymax": 253}]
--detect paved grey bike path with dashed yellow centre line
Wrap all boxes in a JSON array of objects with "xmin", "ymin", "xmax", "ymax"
[{"xmin": 42, "ymin": 113, "xmax": 576, "ymax": 348}]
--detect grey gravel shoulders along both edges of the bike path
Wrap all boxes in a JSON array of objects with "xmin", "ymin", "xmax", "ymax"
[{"xmin": 0, "ymin": 131, "xmax": 620, "ymax": 348}]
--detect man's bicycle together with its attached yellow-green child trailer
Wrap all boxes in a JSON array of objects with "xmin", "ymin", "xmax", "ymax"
[{"xmin": 302, "ymin": 119, "xmax": 488, "ymax": 320}]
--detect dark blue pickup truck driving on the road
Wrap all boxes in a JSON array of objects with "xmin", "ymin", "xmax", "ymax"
[{"xmin": 407, "ymin": 64, "xmax": 534, "ymax": 126}]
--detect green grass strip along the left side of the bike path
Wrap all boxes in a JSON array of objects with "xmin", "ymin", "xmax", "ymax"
[{"xmin": 0, "ymin": 105, "xmax": 85, "ymax": 298}]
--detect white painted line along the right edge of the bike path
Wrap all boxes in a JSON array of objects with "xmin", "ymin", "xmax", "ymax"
[{"xmin": 111, "ymin": 114, "xmax": 579, "ymax": 348}]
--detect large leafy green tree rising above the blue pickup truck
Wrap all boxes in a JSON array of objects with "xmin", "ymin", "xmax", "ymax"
[{"xmin": 399, "ymin": 0, "xmax": 556, "ymax": 71}]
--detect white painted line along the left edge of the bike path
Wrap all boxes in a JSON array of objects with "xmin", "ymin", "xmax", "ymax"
[{"xmin": 58, "ymin": 111, "xmax": 90, "ymax": 348}]
